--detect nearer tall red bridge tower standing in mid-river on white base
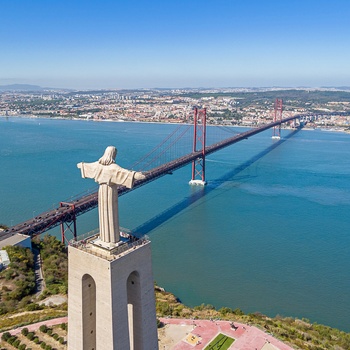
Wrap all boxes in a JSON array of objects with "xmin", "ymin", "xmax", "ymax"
[{"xmin": 189, "ymin": 108, "xmax": 207, "ymax": 186}]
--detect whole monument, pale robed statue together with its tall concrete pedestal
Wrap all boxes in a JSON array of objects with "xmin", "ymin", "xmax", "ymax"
[{"xmin": 68, "ymin": 146, "xmax": 158, "ymax": 350}]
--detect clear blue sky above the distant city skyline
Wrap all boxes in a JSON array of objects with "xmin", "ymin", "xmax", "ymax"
[{"xmin": 0, "ymin": 0, "xmax": 350, "ymax": 89}]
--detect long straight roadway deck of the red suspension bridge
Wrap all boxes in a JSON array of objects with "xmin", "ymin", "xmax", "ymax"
[{"xmin": 0, "ymin": 115, "xmax": 304, "ymax": 241}]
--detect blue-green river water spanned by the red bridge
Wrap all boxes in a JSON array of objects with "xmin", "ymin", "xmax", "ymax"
[{"xmin": 0, "ymin": 118, "xmax": 350, "ymax": 331}]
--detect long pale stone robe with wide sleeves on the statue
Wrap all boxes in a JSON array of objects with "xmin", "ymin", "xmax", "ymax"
[{"xmin": 81, "ymin": 162, "xmax": 135, "ymax": 243}]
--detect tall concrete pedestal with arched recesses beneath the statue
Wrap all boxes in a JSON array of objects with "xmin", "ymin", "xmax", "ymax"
[{"xmin": 68, "ymin": 240, "xmax": 158, "ymax": 350}]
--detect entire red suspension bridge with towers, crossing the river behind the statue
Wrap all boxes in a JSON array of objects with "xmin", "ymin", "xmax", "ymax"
[{"xmin": 0, "ymin": 105, "xmax": 312, "ymax": 242}]
